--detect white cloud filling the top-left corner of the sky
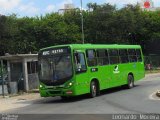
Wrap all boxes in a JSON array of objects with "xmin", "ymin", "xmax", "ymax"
[{"xmin": 0, "ymin": 0, "xmax": 21, "ymax": 10}]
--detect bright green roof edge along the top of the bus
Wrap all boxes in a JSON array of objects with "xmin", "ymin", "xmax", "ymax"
[{"xmin": 40, "ymin": 44, "xmax": 141, "ymax": 51}]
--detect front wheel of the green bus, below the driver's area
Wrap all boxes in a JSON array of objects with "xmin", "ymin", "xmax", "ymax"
[{"xmin": 90, "ymin": 81, "xmax": 98, "ymax": 98}]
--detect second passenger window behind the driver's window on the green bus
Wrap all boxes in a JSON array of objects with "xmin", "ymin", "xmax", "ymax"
[{"xmin": 97, "ymin": 49, "xmax": 109, "ymax": 66}]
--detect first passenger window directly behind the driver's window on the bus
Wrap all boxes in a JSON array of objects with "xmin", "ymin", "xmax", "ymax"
[{"xmin": 86, "ymin": 50, "xmax": 97, "ymax": 67}]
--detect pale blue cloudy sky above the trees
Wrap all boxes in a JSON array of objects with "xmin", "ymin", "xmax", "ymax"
[{"xmin": 0, "ymin": 0, "xmax": 160, "ymax": 17}]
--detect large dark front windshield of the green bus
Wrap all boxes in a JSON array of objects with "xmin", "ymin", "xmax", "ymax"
[{"xmin": 39, "ymin": 54, "xmax": 73, "ymax": 82}]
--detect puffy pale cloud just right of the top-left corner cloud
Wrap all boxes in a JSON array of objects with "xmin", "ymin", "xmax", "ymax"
[{"xmin": 19, "ymin": 2, "xmax": 39, "ymax": 14}]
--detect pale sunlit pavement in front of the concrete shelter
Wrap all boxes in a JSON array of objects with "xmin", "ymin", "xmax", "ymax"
[{"xmin": 0, "ymin": 93, "xmax": 41, "ymax": 113}]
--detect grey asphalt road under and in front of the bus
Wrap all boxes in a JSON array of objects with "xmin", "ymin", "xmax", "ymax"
[{"xmin": 2, "ymin": 74, "xmax": 160, "ymax": 120}]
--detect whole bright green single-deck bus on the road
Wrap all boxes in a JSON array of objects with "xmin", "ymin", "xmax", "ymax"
[{"xmin": 38, "ymin": 44, "xmax": 145, "ymax": 98}]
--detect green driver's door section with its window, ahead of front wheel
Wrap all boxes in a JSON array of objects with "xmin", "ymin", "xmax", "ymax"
[{"xmin": 74, "ymin": 50, "xmax": 90, "ymax": 94}]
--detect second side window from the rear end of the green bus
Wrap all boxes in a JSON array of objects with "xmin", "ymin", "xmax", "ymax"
[{"xmin": 128, "ymin": 49, "xmax": 137, "ymax": 62}]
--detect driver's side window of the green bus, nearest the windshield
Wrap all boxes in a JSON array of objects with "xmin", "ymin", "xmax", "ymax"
[{"xmin": 74, "ymin": 53, "xmax": 87, "ymax": 72}]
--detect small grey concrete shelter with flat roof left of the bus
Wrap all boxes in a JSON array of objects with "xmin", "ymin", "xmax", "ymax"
[{"xmin": 0, "ymin": 54, "xmax": 38, "ymax": 93}]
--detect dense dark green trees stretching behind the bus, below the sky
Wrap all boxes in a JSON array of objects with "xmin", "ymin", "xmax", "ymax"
[{"xmin": 0, "ymin": 3, "xmax": 160, "ymax": 55}]
